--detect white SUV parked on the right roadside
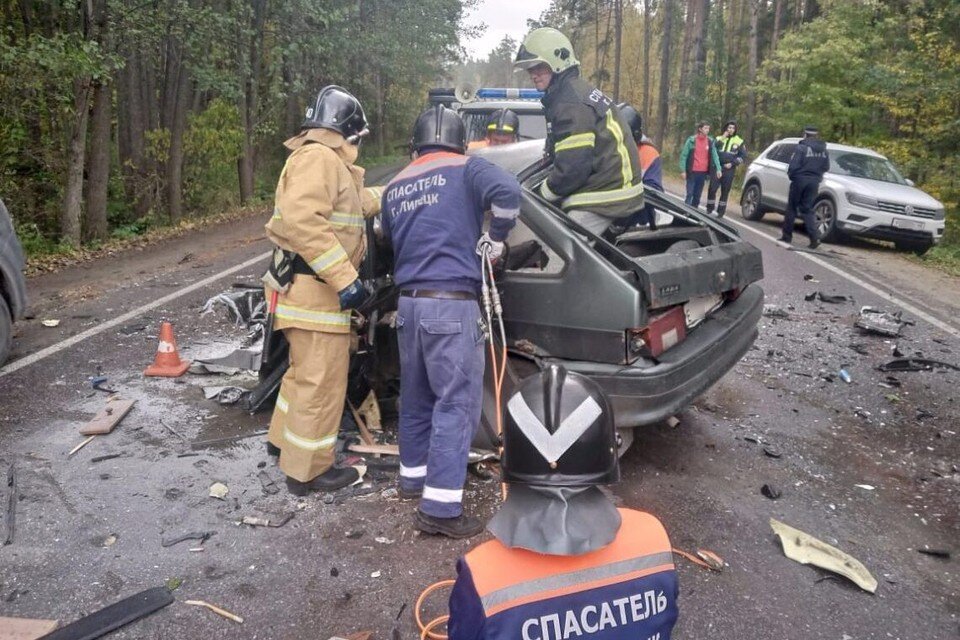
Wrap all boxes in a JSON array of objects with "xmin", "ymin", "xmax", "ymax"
[{"xmin": 740, "ymin": 138, "xmax": 945, "ymax": 254}]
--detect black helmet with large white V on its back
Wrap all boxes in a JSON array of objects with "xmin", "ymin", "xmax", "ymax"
[{"xmin": 501, "ymin": 365, "xmax": 620, "ymax": 487}]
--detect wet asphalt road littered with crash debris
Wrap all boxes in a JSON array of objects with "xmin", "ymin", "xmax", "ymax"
[{"xmin": 0, "ymin": 176, "xmax": 960, "ymax": 640}]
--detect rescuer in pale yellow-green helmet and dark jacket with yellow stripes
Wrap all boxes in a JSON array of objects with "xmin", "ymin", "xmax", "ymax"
[{"xmin": 513, "ymin": 28, "xmax": 643, "ymax": 234}]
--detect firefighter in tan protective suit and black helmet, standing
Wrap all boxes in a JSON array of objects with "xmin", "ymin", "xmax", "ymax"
[{"xmin": 264, "ymin": 86, "xmax": 380, "ymax": 495}]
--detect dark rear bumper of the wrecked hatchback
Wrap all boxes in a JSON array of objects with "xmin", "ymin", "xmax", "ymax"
[{"xmin": 563, "ymin": 284, "xmax": 763, "ymax": 427}]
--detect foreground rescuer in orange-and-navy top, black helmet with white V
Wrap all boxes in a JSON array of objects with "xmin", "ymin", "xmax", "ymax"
[{"xmin": 447, "ymin": 365, "xmax": 679, "ymax": 640}]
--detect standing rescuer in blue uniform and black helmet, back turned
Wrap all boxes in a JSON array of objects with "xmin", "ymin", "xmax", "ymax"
[{"xmin": 381, "ymin": 105, "xmax": 520, "ymax": 538}]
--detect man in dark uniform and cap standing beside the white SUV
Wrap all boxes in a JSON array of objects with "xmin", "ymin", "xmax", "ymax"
[{"xmin": 780, "ymin": 127, "xmax": 830, "ymax": 249}]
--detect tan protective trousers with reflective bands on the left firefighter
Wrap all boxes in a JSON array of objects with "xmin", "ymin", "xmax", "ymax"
[{"xmin": 267, "ymin": 328, "xmax": 350, "ymax": 482}]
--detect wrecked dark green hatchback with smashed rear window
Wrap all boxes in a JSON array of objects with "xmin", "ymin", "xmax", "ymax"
[{"xmin": 351, "ymin": 140, "xmax": 763, "ymax": 446}]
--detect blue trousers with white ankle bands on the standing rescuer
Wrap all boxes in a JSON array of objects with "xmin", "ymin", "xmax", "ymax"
[{"xmin": 397, "ymin": 296, "xmax": 485, "ymax": 518}]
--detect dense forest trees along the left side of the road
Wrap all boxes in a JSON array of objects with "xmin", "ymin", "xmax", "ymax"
[{"xmin": 0, "ymin": 0, "xmax": 473, "ymax": 250}]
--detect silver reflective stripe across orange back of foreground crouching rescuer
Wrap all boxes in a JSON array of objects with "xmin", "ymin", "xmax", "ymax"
[{"xmin": 480, "ymin": 552, "xmax": 673, "ymax": 616}]
